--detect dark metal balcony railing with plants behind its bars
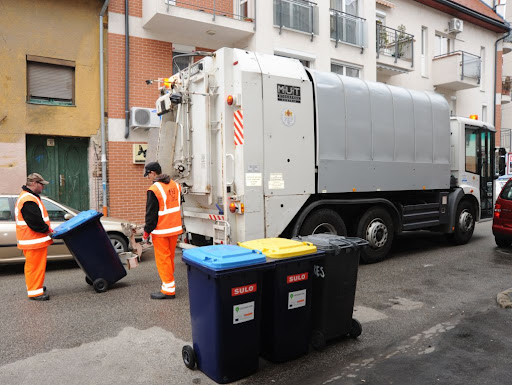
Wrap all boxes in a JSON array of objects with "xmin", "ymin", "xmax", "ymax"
[{"xmin": 376, "ymin": 23, "xmax": 414, "ymax": 67}]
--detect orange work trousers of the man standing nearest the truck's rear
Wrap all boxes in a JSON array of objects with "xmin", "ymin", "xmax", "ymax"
[{"xmin": 153, "ymin": 235, "xmax": 178, "ymax": 295}]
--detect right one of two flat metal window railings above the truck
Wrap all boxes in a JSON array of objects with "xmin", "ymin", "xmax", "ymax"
[{"xmin": 329, "ymin": 8, "xmax": 366, "ymax": 48}]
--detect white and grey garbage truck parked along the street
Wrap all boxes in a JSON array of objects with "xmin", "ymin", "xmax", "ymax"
[{"xmin": 146, "ymin": 48, "xmax": 495, "ymax": 263}]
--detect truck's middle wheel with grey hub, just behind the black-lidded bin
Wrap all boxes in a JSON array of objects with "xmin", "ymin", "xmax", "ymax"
[{"xmin": 357, "ymin": 207, "xmax": 395, "ymax": 263}]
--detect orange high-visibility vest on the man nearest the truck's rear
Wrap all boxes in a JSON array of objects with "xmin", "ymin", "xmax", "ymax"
[{"xmin": 148, "ymin": 181, "xmax": 183, "ymax": 237}]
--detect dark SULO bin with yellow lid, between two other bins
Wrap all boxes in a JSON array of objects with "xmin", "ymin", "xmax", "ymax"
[{"xmin": 240, "ymin": 238, "xmax": 323, "ymax": 362}]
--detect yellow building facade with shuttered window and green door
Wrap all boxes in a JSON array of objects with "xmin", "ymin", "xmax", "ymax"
[{"xmin": 0, "ymin": 0, "xmax": 102, "ymax": 208}]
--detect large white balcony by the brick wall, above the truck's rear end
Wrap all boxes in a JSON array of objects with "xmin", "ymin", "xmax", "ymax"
[{"xmin": 142, "ymin": 0, "xmax": 256, "ymax": 48}]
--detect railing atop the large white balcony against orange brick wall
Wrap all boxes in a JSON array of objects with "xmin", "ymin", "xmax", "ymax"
[{"xmin": 164, "ymin": 0, "xmax": 256, "ymax": 22}]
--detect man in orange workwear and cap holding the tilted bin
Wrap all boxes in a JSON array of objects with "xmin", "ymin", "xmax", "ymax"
[{"xmin": 14, "ymin": 173, "xmax": 53, "ymax": 301}]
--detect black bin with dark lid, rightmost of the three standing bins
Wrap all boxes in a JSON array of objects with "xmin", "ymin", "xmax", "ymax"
[{"xmin": 295, "ymin": 234, "xmax": 368, "ymax": 350}]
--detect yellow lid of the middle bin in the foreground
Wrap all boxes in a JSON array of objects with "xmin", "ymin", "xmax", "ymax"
[{"xmin": 238, "ymin": 238, "xmax": 316, "ymax": 259}]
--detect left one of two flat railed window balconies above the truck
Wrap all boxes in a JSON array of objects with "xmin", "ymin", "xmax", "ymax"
[{"xmin": 274, "ymin": 0, "xmax": 318, "ymax": 40}]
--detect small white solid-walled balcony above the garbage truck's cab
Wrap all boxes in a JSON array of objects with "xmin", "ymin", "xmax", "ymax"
[{"xmin": 432, "ymin": 51, "xmax": 480, "ymax": 91}]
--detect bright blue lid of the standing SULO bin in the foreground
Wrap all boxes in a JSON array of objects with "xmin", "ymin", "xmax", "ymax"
[{"xmin": 183, "ymin": 245, "xmax": 266, "ymax": 271}]
